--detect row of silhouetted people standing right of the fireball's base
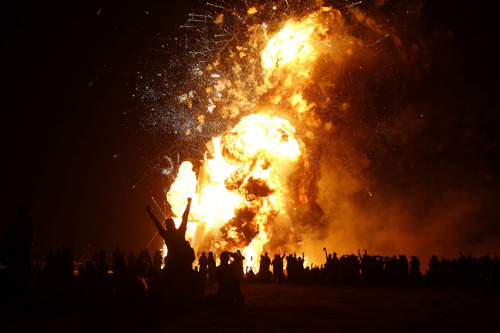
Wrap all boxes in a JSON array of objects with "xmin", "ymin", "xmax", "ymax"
[{"xmin": 252, "ymin": 248, "xmax": 500, "ymax": 291}]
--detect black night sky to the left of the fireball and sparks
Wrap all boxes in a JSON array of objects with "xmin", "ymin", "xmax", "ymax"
[{"xmin": 1, "ymin": 1, "xmax": 193, "ymax": 255}]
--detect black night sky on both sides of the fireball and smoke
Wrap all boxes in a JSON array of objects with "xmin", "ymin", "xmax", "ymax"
[{"xmin": 0, "ymin": 0, "xmax": 500, "ymax": 254}]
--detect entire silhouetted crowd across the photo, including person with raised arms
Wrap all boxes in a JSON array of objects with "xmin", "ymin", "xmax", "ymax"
[{"xmin": 0, "ymin": 199, "xmax": 500, "ymax": 313}]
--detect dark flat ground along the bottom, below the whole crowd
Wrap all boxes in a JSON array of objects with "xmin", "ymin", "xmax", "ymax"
[{"xmin": 0, "ymin": 284, "xmax": 500, "ymax": 332}]
